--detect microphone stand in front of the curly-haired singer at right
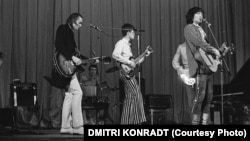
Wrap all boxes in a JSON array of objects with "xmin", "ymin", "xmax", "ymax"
[{"xmin": 205, "ymin": 21, "xmax": 231, "ymax": 124}]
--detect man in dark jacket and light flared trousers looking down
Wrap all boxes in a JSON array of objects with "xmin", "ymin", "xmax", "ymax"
[{"xmin": 55, "ymin": 13, "xmax": 83, "ymax": 134}]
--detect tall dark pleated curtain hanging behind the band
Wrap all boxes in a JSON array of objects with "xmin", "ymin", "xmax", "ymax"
[{"xmin": 0, "ymin": 0, "xmax": 250, "ymax": 125}]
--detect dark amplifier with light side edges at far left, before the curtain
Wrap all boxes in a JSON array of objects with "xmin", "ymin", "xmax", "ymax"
[{"xmin": 10, "ymin": 83, "xmax": 37, "ymax": 107}]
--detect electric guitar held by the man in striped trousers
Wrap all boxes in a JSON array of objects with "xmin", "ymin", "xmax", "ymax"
[{"xmin": 120, "ymin": 46, "xmax": 153, "ymax": 78}]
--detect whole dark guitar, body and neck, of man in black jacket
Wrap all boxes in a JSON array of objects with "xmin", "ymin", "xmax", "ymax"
[{"xmin": 53, "ymin": 52, "xmax": 96, "ymax": 78}]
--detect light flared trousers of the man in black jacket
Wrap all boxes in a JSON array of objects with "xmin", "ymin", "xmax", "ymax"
[{"xmin": 62, "ymin": 74, "xmax": 83, "ymax": 128}]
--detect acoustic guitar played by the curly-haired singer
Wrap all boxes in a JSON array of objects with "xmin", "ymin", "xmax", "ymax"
[{"xmin": 194, "ymin": 43, "xmax": 234, "ymax": 73}]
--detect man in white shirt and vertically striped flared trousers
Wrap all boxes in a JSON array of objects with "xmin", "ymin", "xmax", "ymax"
[{"xmin": 112, "ymin": 23, "xmax": 149, "ymax": 124}]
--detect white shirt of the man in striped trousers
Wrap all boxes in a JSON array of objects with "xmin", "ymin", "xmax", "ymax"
[{"xmin": 112, "ymin": 38, "xmax": 133, "ymax": 64}]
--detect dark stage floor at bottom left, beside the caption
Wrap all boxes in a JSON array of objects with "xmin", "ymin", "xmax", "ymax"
[{"xmin": 0, "ymin": 129, "xmax": 84, "ymax": 141}]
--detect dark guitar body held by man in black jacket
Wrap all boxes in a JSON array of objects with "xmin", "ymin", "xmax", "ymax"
[{"xmin": 53, "ymin": 52, "xmax": 77, "ymax": 78}]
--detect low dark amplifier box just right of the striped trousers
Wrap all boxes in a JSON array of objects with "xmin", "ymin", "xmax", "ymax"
[{"xmin": 146, "ymin": 94, "xmax": 171, "ymax": 109}]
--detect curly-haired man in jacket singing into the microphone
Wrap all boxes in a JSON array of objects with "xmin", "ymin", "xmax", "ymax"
[{"xmin": 184, "ymin": 7, "xmax": 221, "ymax": 125}]
